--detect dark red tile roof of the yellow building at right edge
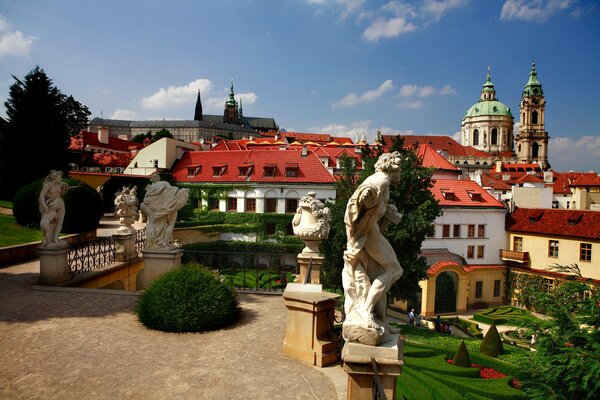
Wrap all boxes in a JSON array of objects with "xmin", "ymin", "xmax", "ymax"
[{"xmin": 506, "ymin": 208, "xmax": 600, "ymax": 240}]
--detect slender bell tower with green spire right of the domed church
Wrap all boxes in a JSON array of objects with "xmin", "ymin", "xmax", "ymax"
[{"xmin": 515, "ymin": 63, "xmax": 549, "ymax": 169}]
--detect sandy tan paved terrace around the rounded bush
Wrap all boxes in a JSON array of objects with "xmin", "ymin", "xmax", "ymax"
[{"xmin": 0, "ymin": 261, "xmax": 346, "ymax": 400}]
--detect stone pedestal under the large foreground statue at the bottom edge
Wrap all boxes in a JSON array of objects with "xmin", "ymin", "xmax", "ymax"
[{"xmin": 342, "ymin": 334, "xmax": 404, "ymax": 400}]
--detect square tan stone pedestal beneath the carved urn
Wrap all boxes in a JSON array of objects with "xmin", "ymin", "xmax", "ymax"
[{"xmin": 282, "ymin": 285, "xmax": 340, "ymax": 367}]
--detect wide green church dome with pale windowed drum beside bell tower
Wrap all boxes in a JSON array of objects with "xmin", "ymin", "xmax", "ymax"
[{"xmin": 461, "ymin": 67, "xmax": 514, "ymax": 155}]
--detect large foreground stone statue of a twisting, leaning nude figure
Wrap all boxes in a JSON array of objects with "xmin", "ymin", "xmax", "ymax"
[{"xmin": 342, "ymin": 152, "xmax": 403, "ymax": 345}]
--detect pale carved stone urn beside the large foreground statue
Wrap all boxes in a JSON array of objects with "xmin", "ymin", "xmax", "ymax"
[{"xmin": 292, "ymin": 192, "xmax": 331, "ymax": 254}]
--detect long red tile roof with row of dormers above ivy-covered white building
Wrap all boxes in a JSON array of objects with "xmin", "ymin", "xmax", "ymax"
[{"xmin": 172, "ymin": 149, "xmax": 335, "ymax": 184}]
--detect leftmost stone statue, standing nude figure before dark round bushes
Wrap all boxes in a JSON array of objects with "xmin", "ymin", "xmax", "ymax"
[{"xmin": 38, "ymin": 170, "xmax": 69, "ymax": 247}]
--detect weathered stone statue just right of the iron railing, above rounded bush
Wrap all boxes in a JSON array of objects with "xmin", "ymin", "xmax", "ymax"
[{"xmin": 140, "ymin": 174, "xmax": 189, "ymax": 250}]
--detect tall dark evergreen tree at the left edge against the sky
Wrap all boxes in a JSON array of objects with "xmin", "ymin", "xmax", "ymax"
[{"xmin": 0, "ymin": 67, "xmax": 90, "ymax": 199}]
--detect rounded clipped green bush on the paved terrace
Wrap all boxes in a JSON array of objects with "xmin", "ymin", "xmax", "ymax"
[{"xmin": 136, "ymin": 264, "xmax": 240, "ymax": 332}]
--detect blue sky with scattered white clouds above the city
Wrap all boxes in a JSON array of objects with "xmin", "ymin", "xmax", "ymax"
[{"xmin": 0, "ymin": 0, "xmax": 600, "ymax": 172}]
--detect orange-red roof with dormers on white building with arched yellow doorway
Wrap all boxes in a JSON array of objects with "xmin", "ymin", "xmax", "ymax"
[{"xmin": 430, "ymin": 179, "xmax": 504, "ymax": 208}]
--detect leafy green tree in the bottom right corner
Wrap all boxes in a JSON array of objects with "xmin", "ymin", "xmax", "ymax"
[{"xmin": 521, "ymin": 264, "xmax": 600, "ymax": 399}]
